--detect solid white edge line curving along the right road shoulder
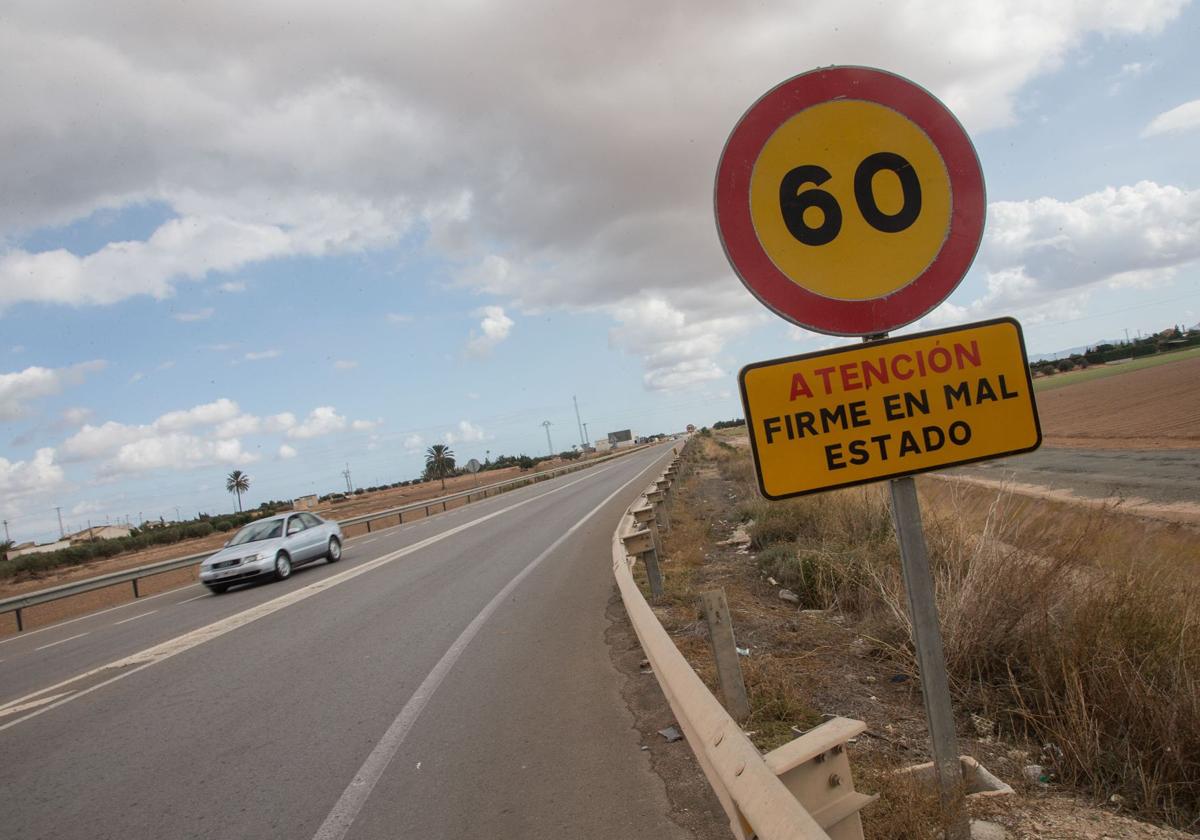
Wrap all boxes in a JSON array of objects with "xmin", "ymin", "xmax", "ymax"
[{"xmin": 313, "ymin": 448, "xmax": 659, "ymax": 840}]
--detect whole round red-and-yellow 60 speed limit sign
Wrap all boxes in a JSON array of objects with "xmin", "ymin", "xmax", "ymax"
[{"xmin": 714, "ymin": 67, "xmax": 986, "ymax": 335}]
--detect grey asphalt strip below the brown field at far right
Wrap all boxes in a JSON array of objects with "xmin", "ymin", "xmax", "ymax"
[{"xmin": 947, "ymin": 446, "xmax": 1200, "ymax": 504}]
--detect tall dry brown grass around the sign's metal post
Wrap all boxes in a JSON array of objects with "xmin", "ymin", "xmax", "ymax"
[{"xmin": 694, "ymin": 438, "xmax": 1200, "ymax": 836}]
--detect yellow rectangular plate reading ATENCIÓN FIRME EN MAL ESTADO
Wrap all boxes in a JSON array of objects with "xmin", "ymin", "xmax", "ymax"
[{"xmin": 738, "ymin": 318, "xmax": 1042, "ymax": 499}]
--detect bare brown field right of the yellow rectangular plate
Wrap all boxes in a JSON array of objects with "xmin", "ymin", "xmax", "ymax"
[{"xmin": 1037, "ymin": 358, "xmax": 1200, "ymax": 449}]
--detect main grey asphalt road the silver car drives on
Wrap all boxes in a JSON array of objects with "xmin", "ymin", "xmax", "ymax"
[{"xmin": 0, "ymin": 446, "xmax": 688, "ymax": 840}]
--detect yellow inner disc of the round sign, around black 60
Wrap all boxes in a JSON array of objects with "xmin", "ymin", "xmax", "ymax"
[{"xmin": 750, "ymin": 100, "xmax": 950, "ymax": 300}]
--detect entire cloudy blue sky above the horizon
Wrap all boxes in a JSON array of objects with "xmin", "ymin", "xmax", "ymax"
[{"xmin": 0, "ymin": 0, "xmax": 1200, "ymax": 541}]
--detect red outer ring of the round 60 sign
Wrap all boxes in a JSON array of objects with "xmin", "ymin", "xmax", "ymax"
[{"xmin": 713, "ymin": 67, "xmax": 986, "ymax": 336}]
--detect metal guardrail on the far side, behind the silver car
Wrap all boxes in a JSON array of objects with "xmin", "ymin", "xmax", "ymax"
[{"xmin": 0, "ymin": 445, "xmax": 647, "ymax": 632}]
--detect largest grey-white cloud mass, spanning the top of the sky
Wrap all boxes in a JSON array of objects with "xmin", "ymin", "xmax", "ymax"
[{"xmin": 0, "ymin": 0, "xmax": 1183, "ymax": 386}]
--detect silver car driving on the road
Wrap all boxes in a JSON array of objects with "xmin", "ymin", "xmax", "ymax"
[{"xmin": 200, "ymin": 514, "xmax": 342, "ymax": 594}]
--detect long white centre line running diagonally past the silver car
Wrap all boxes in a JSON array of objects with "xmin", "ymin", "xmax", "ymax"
[{"xmin": 0, "ymin": 464, "xmax": 628, "ymax": 732}]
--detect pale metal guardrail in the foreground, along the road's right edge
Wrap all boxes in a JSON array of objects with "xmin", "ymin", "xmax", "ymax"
[{"xmin": 612, "ymin": 450, "xmax": 875, "ymax": 840}]
